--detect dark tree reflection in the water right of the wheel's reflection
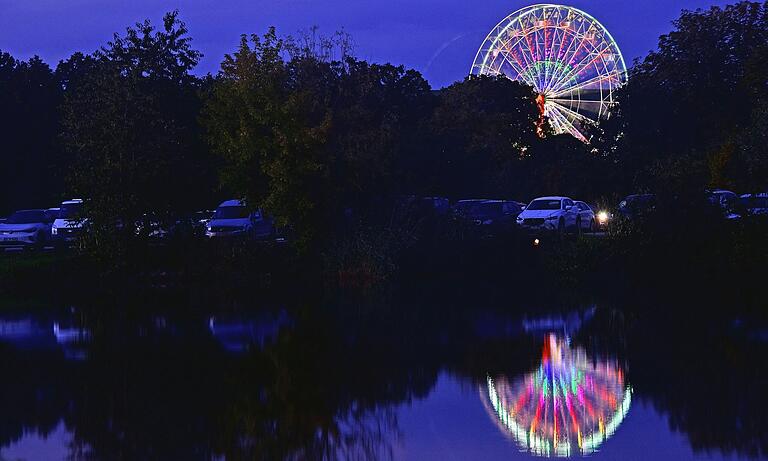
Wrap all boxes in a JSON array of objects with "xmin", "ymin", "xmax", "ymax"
[{"xmin": 579, "ymin": 300, "xmax": 768, "ymax": 457}]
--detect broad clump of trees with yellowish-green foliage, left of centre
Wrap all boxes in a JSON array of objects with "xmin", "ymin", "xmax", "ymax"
[{"xmin": 205, "ymin": 29, "xmax": 430, "ymax": 249}]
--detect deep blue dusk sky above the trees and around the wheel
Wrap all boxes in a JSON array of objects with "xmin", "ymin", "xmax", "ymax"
[{"xmin": 0, "ymin": 0, "xmax": 726, "ymax": 87}]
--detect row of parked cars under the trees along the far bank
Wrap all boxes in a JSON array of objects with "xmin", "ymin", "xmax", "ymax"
[{"xmin": 0, "ymin": 190, "xmax": 768, "ymax": 255}]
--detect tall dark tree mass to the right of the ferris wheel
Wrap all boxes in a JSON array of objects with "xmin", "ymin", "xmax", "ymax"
[{"xmin": 604, "ymin": 1, "xmax": 768, "ymax": 194}]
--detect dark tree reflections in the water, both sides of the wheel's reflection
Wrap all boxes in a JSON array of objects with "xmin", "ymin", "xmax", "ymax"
[{"xmin": 0, "ymin": 300, "xmax": 768, "ymax": 459}]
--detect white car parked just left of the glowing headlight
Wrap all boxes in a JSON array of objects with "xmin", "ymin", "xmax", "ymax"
[{"xmin": 517, "ymin": 196, "xmax": 584, "ymax": 233}]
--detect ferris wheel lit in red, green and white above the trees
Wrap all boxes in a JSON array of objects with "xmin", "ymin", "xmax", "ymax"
[{"xmin": 471, "ymin": 4, "xmax": 627, "ymax": 142}]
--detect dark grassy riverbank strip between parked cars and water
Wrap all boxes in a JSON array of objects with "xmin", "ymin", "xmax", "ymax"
[{"xmin": 0, "ymin": 213, "xmax": 768, "ymax": 315}]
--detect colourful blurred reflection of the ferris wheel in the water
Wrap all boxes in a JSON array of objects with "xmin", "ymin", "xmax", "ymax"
[{"xmin": 481, "ymin": 334, "xmax": 632, "ymax": 457}]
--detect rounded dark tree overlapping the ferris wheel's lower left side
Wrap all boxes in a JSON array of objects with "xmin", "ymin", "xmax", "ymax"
[{"xmin": 426, "ymin": 76, "xmax": 539, "ymax": 198}]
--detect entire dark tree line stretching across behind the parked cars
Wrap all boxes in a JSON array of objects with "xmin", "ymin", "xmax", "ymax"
[{"xmin": 0, "ymin": 2, "xmax": 768, "ymax": 252}]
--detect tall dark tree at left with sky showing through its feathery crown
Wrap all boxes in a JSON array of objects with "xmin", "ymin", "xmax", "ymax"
[{"xmin": 59, "ymin": 12, "xmax": 216, "ymax": 257}]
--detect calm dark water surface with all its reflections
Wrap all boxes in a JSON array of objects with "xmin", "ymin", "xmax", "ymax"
[{"xmin": 0, "ymin": 292, "xmax": 768, "ymax": 460}]
